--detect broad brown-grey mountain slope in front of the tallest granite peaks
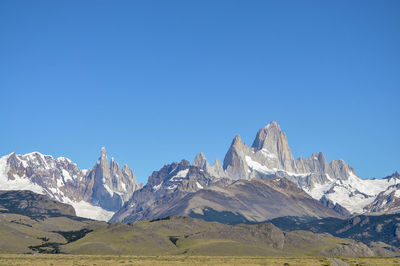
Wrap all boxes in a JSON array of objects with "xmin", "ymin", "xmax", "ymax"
[{"xmin": 111, "ymin": 159, "xmax": 342, "ymax": 223}]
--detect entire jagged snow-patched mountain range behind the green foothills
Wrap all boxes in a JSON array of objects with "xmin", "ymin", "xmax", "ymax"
[{"xmin": 0, "ymin": 121, "xmax": 400, "ymax": 224}]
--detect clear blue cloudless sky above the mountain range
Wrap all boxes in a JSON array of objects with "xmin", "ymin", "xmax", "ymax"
[{"xmin": 0, "ymin": 0, "xmax": 400, "ymax": 182}]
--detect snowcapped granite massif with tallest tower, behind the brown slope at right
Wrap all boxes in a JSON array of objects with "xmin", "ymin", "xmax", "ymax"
[{"xmin": 193, "ymin": 121, "xmax": 400, "ymax": 213}]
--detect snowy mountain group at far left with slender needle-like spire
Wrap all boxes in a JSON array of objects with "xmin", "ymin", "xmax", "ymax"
[{"xmin": 0, "ymin": 148, "xmax": 139, "ymax": 221}]
